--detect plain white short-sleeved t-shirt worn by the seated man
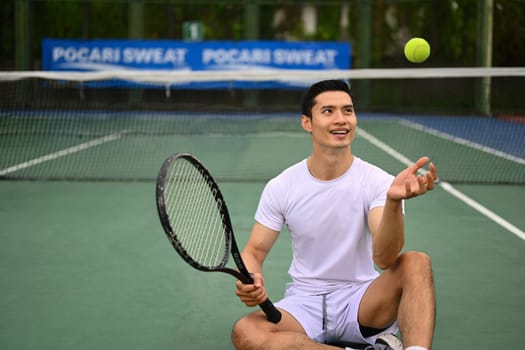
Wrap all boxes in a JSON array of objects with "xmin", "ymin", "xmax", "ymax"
[{"xmin": 255, "ymin": 157, "xmax": 394, "ymax": 293}]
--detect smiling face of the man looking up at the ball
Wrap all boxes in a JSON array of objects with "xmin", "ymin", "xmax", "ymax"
[{"xmin": 301, "ymin": 91, "xmax": 357, "ymax": 149}]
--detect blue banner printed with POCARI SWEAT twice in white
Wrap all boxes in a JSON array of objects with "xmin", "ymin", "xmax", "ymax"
[{"xmin": 42, "ymin": 39, "xmax": 352, "ymax": 87}]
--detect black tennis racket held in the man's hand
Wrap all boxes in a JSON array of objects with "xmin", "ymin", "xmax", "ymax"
[{"xmin": 156, "ymin": 153, "xmax": 281, "ymax": 323}]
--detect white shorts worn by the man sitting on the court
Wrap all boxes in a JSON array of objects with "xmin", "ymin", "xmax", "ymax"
[{"xmin": 275, "ymin": 281, "xmax": 399, "ymax": 344}]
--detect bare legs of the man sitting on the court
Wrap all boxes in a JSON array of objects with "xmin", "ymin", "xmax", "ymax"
[{"xmin": 232, "ymin": 252, "xmax": 435, "ymax": 350}]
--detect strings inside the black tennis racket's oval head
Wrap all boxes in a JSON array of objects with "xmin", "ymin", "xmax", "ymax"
[{"xmin": 164, "ymin": 159, "xmax": 228, "ymax": 268}]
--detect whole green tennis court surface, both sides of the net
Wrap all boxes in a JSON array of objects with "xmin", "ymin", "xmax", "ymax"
[{"xmin": 0, "ymin": 108, "xmax": 525, "ymax": 350}]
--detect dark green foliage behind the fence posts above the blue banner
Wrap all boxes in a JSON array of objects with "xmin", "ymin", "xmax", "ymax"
[{"xmin": 0, "ymin": 0, "xmax": 525, "ymax": 70}]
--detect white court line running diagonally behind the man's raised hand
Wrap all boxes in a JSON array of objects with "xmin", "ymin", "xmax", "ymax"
[{"xmin": 357, "ymin": 128, "xmax": 525, "ymax": 240}]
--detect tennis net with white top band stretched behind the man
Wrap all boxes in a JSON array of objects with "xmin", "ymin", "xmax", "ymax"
[{"xmin": 0, "ymin": 67, "xmax": 525, "ymax": 184}]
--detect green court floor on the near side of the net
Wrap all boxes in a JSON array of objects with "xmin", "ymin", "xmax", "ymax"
[{"xmin": 0, "ymin": 181, "xmax": 525, "ymax": 350}]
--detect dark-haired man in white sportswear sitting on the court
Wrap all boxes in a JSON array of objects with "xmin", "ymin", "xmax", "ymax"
[{"xmin": 232, "ymin": 80, "xmax": 437, "ymax": 350}]
